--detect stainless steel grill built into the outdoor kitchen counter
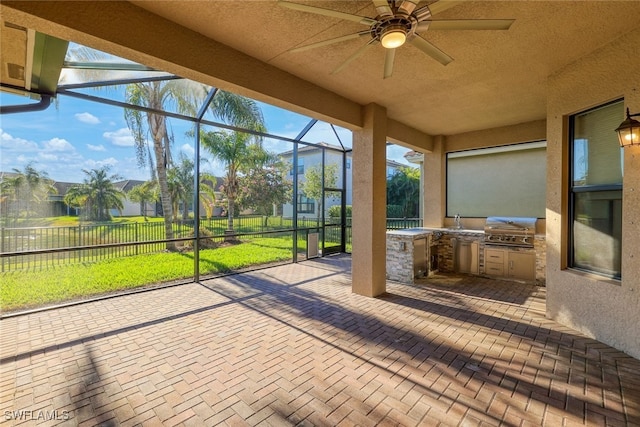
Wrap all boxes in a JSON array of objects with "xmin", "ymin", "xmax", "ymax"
[{"xmin": 484, "ymin": 216, "xmax": 537, "ymax": 248}]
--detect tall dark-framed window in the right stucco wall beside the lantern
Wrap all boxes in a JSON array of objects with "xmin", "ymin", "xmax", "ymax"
[{"xmin": 568, "ymin": 101, "xmax": 624, "ymax": 279}]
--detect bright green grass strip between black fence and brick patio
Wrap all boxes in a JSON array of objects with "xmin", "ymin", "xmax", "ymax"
[{"xmin": 0, "ymin": 237, "xmax": 292, "ymax": 311}]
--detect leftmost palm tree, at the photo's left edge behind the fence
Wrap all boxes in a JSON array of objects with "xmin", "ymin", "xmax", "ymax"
[{"xmin": 0, "ymin": 163, "xmax": 58, "ymax": 221}]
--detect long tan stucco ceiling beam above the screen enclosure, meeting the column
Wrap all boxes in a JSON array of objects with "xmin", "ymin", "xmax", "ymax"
[{"xmin": 0, "ymin": 0, "xmax": 430, "ymax": 149}]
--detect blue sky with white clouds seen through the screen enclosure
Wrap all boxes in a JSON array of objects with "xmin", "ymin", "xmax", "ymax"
[{"xmin": 0, "ymin": 88, "xmax": 407, "ymax": 182}]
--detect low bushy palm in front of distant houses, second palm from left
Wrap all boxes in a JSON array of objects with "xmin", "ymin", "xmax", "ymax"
[{"xmin": 64, "ymin": 166, "xmax": 126, "ymax": 221}]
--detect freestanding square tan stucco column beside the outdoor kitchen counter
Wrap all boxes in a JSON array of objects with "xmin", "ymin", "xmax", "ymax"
[{"xmin": 351, "ymin": 104, "xmax": 387, "ymax": 297}]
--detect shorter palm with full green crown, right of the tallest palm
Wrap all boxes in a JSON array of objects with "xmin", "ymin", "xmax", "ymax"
[{"xmin": 201, "ymin": 131, "xmax": 269, "ymax": 233}]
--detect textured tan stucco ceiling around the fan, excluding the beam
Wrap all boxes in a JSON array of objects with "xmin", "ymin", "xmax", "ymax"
[{"xmin": 129, "ymin": 0, "xmax": 640, "ymax": 135}]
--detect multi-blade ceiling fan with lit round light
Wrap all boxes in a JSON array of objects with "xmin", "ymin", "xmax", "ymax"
[{"xmin": 278, "ymin": 0, "xmax": 515, "ymax": 79}]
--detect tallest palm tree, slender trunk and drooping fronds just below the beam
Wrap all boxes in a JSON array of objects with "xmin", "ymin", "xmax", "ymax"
[{"xmin": 125, "ymin": 79, "xmax": 263, "ymax": 250}]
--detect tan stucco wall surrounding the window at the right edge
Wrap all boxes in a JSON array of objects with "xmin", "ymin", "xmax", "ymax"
[{"xmin": 547, "ymin": 28, "xmax": 640, "ymax": 358}]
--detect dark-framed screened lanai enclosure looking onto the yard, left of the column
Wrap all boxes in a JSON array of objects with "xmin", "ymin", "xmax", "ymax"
[{"xmin": 0, "ymin": 36, "xmax": 419, "ymax": 311}]
